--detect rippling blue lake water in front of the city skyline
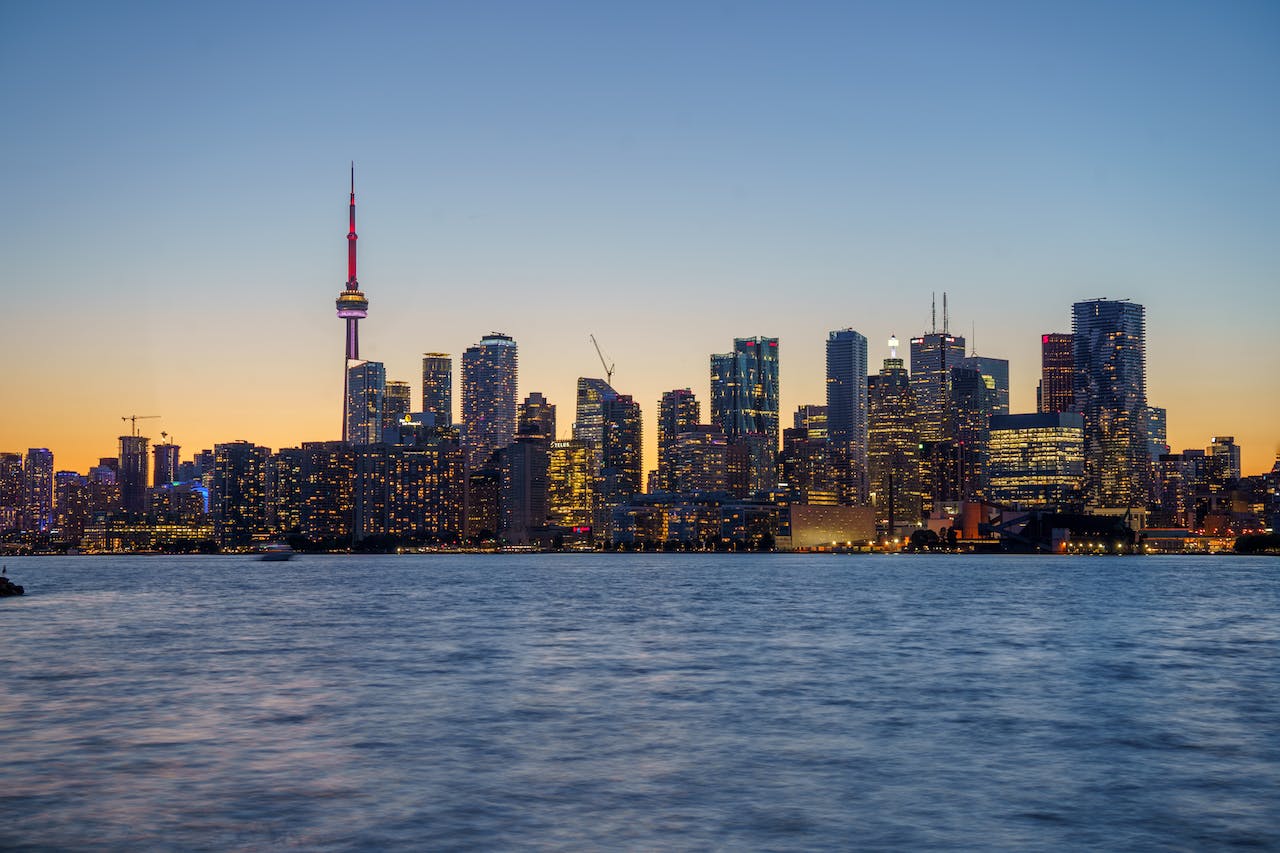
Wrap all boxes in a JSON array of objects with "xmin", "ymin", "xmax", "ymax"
[{"xmin": 0, "ymin": 555, "xmax": 1280, "ymax": 850}]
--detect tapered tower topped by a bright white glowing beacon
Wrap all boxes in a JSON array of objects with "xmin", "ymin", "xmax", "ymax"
[{"xmin": 867, "ymin": 338, "xmax": 922, "ymax": 537}]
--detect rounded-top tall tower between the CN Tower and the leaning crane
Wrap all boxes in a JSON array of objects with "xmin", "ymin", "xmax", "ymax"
[{"xmin": 462, "ymin": 332, "xmax": 520, "ymax": 470}]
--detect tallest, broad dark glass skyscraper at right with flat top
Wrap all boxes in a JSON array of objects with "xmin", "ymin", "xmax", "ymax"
[{"xmin": 1071, "ymin": 300, "xmax": 1151, "ymax": 507}]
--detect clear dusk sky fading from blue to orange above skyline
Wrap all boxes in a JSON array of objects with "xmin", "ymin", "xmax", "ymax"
[{"xmin": 0, "ymin": 0, "xmax": 1280, "ymax": 474}]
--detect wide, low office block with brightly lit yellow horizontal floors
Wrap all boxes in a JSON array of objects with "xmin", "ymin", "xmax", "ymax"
[{"xmin": 987, "ymin": 412, "xmax": 1084, "ymax": 511}]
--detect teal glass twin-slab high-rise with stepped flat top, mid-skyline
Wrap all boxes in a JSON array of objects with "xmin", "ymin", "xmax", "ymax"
[{"xmin": 712, "ymin": 337, "xmax": 780, "ymax": 456}]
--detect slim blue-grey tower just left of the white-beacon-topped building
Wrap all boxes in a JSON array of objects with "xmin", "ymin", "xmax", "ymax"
[{"xmin": 827, "ymin": 329, "xmax": 867, "ymax": 505}]
